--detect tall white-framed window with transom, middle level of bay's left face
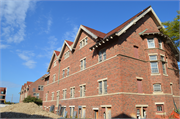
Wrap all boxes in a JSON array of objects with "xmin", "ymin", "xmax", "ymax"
[{"xmin": 149, "ymin": 55, "xmax": 159, "ymax": 74}]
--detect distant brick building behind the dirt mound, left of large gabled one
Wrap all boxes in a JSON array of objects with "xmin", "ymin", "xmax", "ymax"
[{"xmin": 19, "ymin": 74, "xmax": 48, "ymax": 102}]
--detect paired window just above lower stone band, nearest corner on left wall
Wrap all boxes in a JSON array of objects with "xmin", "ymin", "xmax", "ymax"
[{"xmin": 99, "ymin": 80, "xmax": 107, "ymax": 94}]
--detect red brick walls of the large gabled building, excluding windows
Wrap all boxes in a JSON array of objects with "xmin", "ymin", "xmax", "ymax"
[{"xmin": 43, "ymin": 14, "xmax": 179, "ymax": 118}]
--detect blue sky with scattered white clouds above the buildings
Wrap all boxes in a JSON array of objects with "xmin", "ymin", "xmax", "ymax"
[{"xmin": 0, "ymin": 0, "xmax": 179, "ymax": 102}]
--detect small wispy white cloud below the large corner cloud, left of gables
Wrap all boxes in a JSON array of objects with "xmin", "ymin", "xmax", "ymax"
[{"xmin": 17, "ymin": 50, "xmax": 36, "ymax": 69}]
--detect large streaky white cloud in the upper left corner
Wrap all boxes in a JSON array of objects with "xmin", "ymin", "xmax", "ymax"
[{"xmin": 0, "ymin": 0, "xmax": 35, "ymax": 43}]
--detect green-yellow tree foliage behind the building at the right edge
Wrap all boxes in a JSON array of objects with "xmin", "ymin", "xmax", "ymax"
[{"xmin": 161, "ymin": 11, "xmax": 180, "ymax": 47}]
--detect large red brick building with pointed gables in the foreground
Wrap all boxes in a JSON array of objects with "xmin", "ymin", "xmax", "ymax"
[{"xmin": 43, "ymin": 6, "xmax": 180, "ymax": 119}]
